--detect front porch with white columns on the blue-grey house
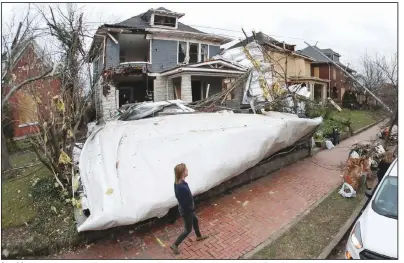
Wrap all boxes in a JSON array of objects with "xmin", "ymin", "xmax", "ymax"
[{"xmin": 154, "ymin": 60, "xmax": 246, "ymax": 102}]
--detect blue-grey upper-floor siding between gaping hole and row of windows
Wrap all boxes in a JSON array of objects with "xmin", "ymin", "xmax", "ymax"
[{"xmin": 149, "ymin": 39, "xmax": 178, "ymax": 73}]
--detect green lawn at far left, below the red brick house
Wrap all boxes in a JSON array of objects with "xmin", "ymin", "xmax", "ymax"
[{"xmin": 1, "ymin": 152, "xmax": 51, "ymax": 228}]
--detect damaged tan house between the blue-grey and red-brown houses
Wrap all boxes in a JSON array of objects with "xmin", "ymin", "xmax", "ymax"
[{"xmin": 229, "ymin": 32, "xmax": 329, "ymax": 102}]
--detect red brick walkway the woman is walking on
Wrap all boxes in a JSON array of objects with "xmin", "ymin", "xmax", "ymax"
[{"xmin": 56, "ymin": 123, "xmax": 379, "ymax": 259}]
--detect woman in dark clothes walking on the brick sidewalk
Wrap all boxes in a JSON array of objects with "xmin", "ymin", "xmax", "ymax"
[{"xmin": 170, "ymin": 163, "xmax": 208, "ymax": 254}]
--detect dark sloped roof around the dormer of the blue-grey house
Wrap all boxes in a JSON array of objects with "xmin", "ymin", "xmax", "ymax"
[{"xmin": 105, "ymin": 7, "xmax": 206, "ymax": 34}]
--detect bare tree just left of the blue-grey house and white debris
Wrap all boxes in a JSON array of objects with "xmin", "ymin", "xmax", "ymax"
[{"xmin": 27, "ymin": 4, "xmax": 97, "ymax": 192}]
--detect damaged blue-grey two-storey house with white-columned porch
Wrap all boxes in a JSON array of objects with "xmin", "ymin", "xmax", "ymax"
[{"xmin": 90, "ymin": 7, "xmax": 245, "ymax": 120}]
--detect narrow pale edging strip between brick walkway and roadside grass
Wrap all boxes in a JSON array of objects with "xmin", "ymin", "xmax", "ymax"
[{"xmin": 239, "ymin": 184, "xmax": 346, "ymax": 259}]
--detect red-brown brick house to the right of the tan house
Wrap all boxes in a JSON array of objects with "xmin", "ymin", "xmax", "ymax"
[{"xmin": 299, "ymin": 47, "xmax": 355, "ymax": 103}]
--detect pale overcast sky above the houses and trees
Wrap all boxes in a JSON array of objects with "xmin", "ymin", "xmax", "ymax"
[{"xmin": 2, "ymin": 3, "xmax": 397, "ymax": 71}]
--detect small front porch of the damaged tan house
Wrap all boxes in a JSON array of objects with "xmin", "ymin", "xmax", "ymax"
[{"xmin": 290, "ymin": 77, "xmax": 329, "ymax": 105}]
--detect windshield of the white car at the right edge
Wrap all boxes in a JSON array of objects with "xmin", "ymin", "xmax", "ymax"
[{"xmin": 372, "ymin": 176, "xmax": 398, "ymax": 219}]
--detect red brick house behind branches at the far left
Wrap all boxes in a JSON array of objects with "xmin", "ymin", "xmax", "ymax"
[{"xmin": 2, "ymin": 41, "xmax": 60, "ymax": 139}]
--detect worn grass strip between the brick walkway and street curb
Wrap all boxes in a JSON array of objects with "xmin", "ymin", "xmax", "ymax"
[{"xmin": 252, "ymin": 188, "xmax": 364, "ymax": 259}]
